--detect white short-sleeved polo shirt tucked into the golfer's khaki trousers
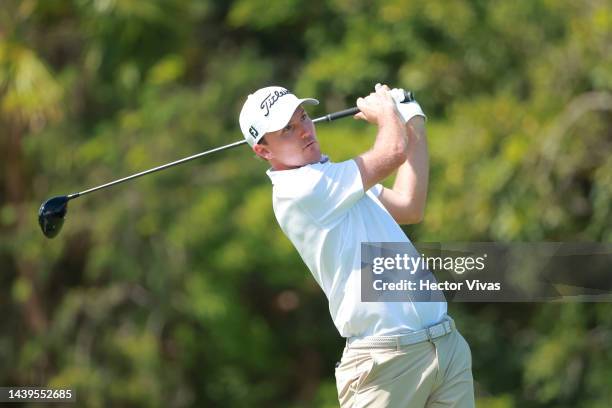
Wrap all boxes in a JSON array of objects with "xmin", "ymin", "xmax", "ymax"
[{"xmin": 267, "ymin": 160, "xmax": 446, "ymax": 338}]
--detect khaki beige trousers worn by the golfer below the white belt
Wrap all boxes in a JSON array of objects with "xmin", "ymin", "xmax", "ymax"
[{"xmin": 336, "ymin": 330, "xmax": 474, "ymax": 408}]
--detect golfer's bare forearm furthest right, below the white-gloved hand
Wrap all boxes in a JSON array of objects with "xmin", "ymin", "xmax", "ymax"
[{"xmin": 393, "ymin": 116, "xmax": 429, "ymax": 220}]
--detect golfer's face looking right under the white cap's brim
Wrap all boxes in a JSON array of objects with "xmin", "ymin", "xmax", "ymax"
[{"xmin": 253, "ymin": 106, "xmax": 321, "ymax": 170}]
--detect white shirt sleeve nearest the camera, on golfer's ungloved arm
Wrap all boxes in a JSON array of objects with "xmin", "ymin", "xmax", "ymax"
[{"xmin": 299, "ymin": 160, "xmax": 364, "ymax": 224}]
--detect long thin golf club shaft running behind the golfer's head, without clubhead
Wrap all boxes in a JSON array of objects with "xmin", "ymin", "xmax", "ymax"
[{"xmin": 67, "ymin": 92, "xmax": 414, "ymax": 200}]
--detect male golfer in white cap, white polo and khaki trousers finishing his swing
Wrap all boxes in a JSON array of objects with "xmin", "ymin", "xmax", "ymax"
[{"xmin": 240, "ymin": 84, "xmax": 474, "ymax": 408}]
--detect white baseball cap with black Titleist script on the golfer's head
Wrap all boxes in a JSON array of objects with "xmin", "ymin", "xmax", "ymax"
[{"xmin": 239, "ymin": 86, "xmax": 319, "ymax": 146}]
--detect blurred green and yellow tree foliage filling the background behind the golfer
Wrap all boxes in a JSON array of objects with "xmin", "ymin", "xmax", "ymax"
[{"xmin": 0, "ymin": 0, "xmax": 612, "ymax": 408}]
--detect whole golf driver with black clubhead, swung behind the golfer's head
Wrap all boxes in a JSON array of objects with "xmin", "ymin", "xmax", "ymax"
[{"xmin": 38, "ymin": 91, "xmax": 414, "ymax": 238}]
